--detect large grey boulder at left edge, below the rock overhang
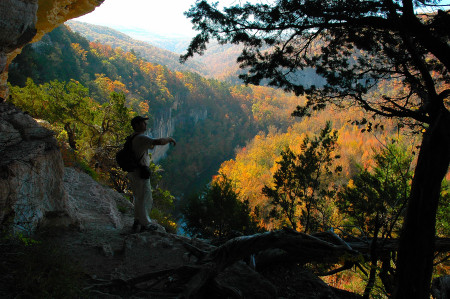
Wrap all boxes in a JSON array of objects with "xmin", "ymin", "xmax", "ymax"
[{"xmin": 0, "ymin": 103, "xmax": 71, "ymax": 233}]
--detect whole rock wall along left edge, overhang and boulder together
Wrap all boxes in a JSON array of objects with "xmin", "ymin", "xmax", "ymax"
[{"xmin": 0, "ymin": 0, "xmax": 103, "ymax": 233}]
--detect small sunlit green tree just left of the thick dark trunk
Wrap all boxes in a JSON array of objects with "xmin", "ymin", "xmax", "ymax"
[{"xmin": 336, "ymin": 141, "xmax": 413, "ymax": 296}]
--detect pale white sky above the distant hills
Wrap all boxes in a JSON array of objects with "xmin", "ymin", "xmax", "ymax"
[{"xmin": 75, "ymin": 0, "xmax": 450, "ymax": 38}]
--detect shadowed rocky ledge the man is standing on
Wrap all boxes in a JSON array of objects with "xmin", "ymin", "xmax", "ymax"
[{"xmin": 31, "ymin": 168, "xmax": 357, "ymax": 298}]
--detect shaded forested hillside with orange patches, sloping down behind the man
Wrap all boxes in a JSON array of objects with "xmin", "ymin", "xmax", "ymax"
[{"xmin": 9, "ymin": 26, "xmax": 302, "ymax": 194}]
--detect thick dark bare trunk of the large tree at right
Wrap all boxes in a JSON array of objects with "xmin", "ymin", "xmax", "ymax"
[{"xmin": 394, "ymin": 108, "xmax": 450, "ymax": 299}]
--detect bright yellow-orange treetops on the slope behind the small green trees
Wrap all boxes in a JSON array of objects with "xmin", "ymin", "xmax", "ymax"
[{"xmin": 215, "ymin": 104, "xmax": 417, "ymax": 229}]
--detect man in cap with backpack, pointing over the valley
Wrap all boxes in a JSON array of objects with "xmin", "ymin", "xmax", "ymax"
[{"xmin": 128, "ymin": 116, "xmax": 176, "ymax": 232}]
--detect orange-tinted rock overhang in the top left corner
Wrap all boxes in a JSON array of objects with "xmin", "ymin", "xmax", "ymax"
[{"xmin": 0, "ymin": 0, "xmax": 104, "ymax": 99}]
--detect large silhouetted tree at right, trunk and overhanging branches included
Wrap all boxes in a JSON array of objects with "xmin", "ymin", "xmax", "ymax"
[{"xmin": 182, "ymin": 0, "xmax": 450, "ymax": 298}]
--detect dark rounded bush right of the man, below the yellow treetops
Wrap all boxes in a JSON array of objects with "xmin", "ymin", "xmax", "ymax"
[{"xmin": 183, "ymin": 176, "xmax": 256, "ymax": 239}]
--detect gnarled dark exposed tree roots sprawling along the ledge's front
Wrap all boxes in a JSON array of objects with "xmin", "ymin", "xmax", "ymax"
[{"xmin": 87, "ymin": 229, "xmax": 450, "ymax": 298}]
